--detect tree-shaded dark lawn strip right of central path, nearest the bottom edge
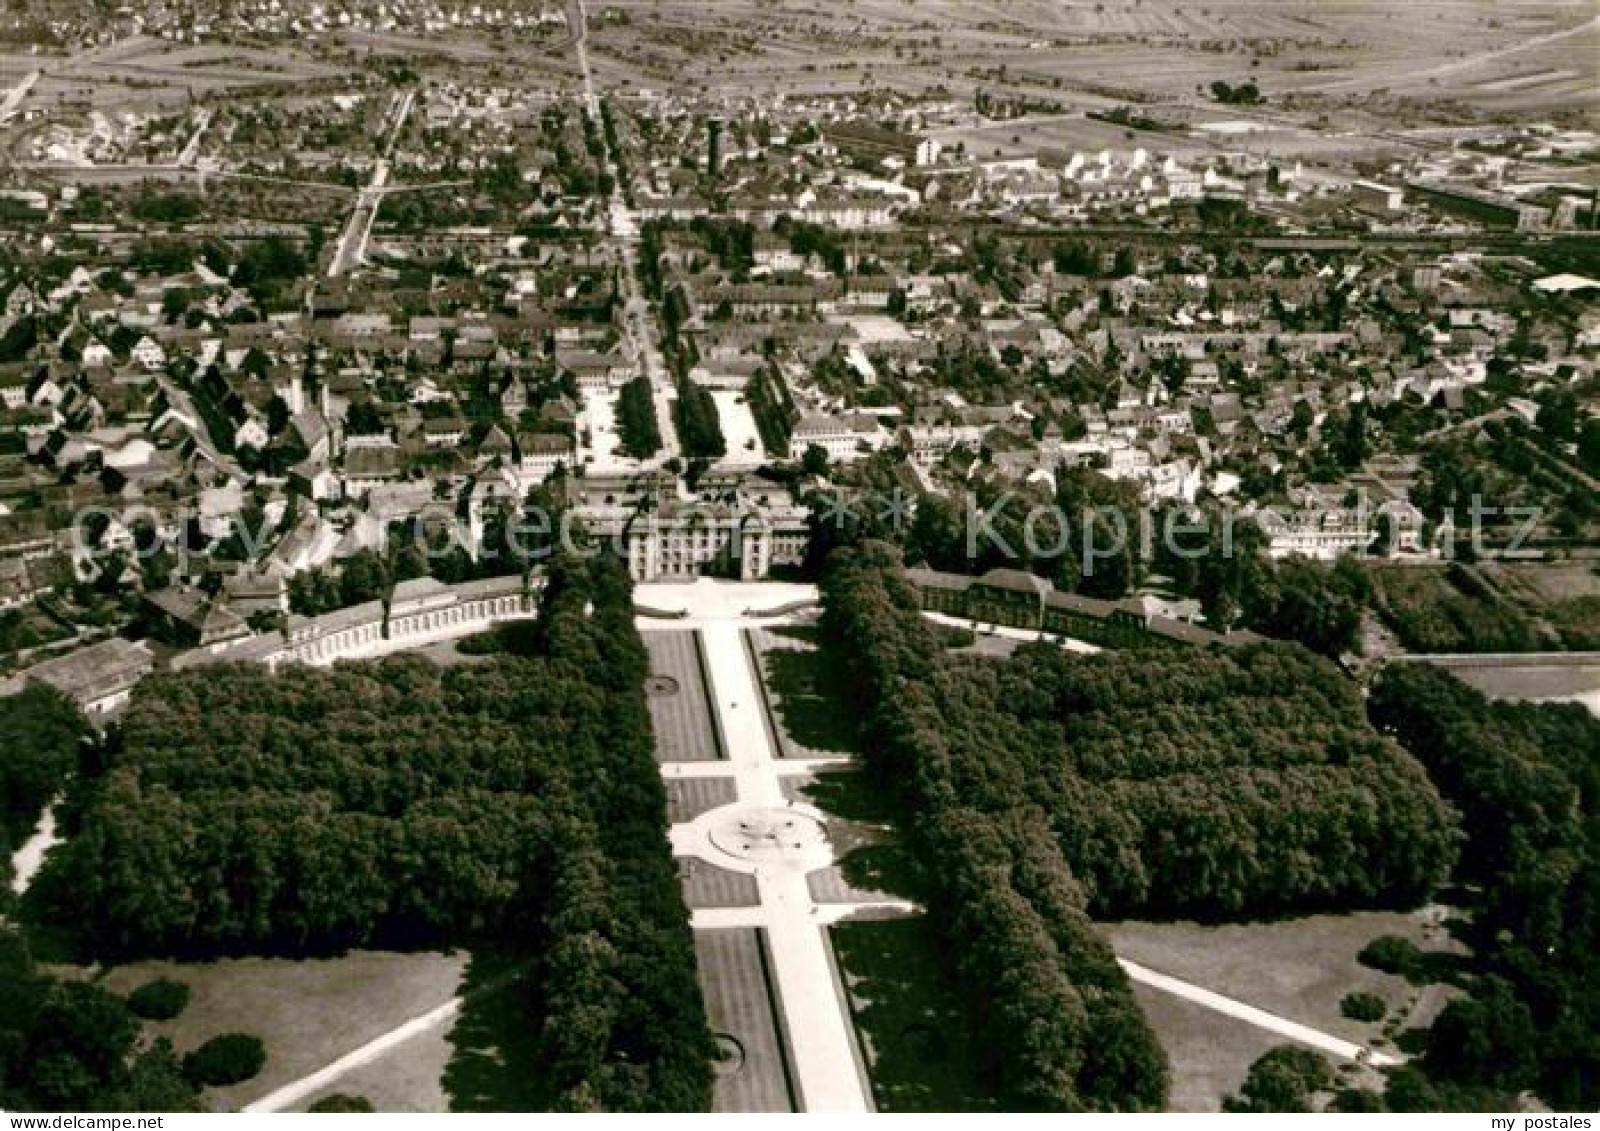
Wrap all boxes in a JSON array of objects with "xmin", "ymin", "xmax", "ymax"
[{"xmin": 829, "ymin": 917, "xmax": 994, "ymax": 1112}]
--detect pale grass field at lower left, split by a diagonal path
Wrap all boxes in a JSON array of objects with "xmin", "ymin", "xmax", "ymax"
[{"xmin": 96, "ymin": 952, "xmax": 467, "ymax": 1110}]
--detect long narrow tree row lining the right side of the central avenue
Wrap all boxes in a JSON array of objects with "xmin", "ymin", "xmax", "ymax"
[{"xmin": 824, "ymin": 544, "xmax": 1166, "ymax": 1110}]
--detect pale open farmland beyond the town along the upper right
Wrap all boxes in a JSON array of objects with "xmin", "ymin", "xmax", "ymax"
[{"xmin": 594, "ymin": 0, "xmax": 1600, "ymax": 120}]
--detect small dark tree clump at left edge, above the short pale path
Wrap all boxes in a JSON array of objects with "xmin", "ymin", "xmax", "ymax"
[{"xmin": 0, "ymin": 685, "xmax": 90, "ymax": 870}]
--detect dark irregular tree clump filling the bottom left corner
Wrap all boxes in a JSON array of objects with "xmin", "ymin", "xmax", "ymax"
[{"xmin": 0, "ymin": 926, "xmax": 198, "ymax": 1112}]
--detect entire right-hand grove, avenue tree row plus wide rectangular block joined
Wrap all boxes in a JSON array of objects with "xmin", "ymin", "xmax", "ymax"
[{"xmin": 822, "ymin": 542, "xmax": 1458, "ymax": 1109}]
